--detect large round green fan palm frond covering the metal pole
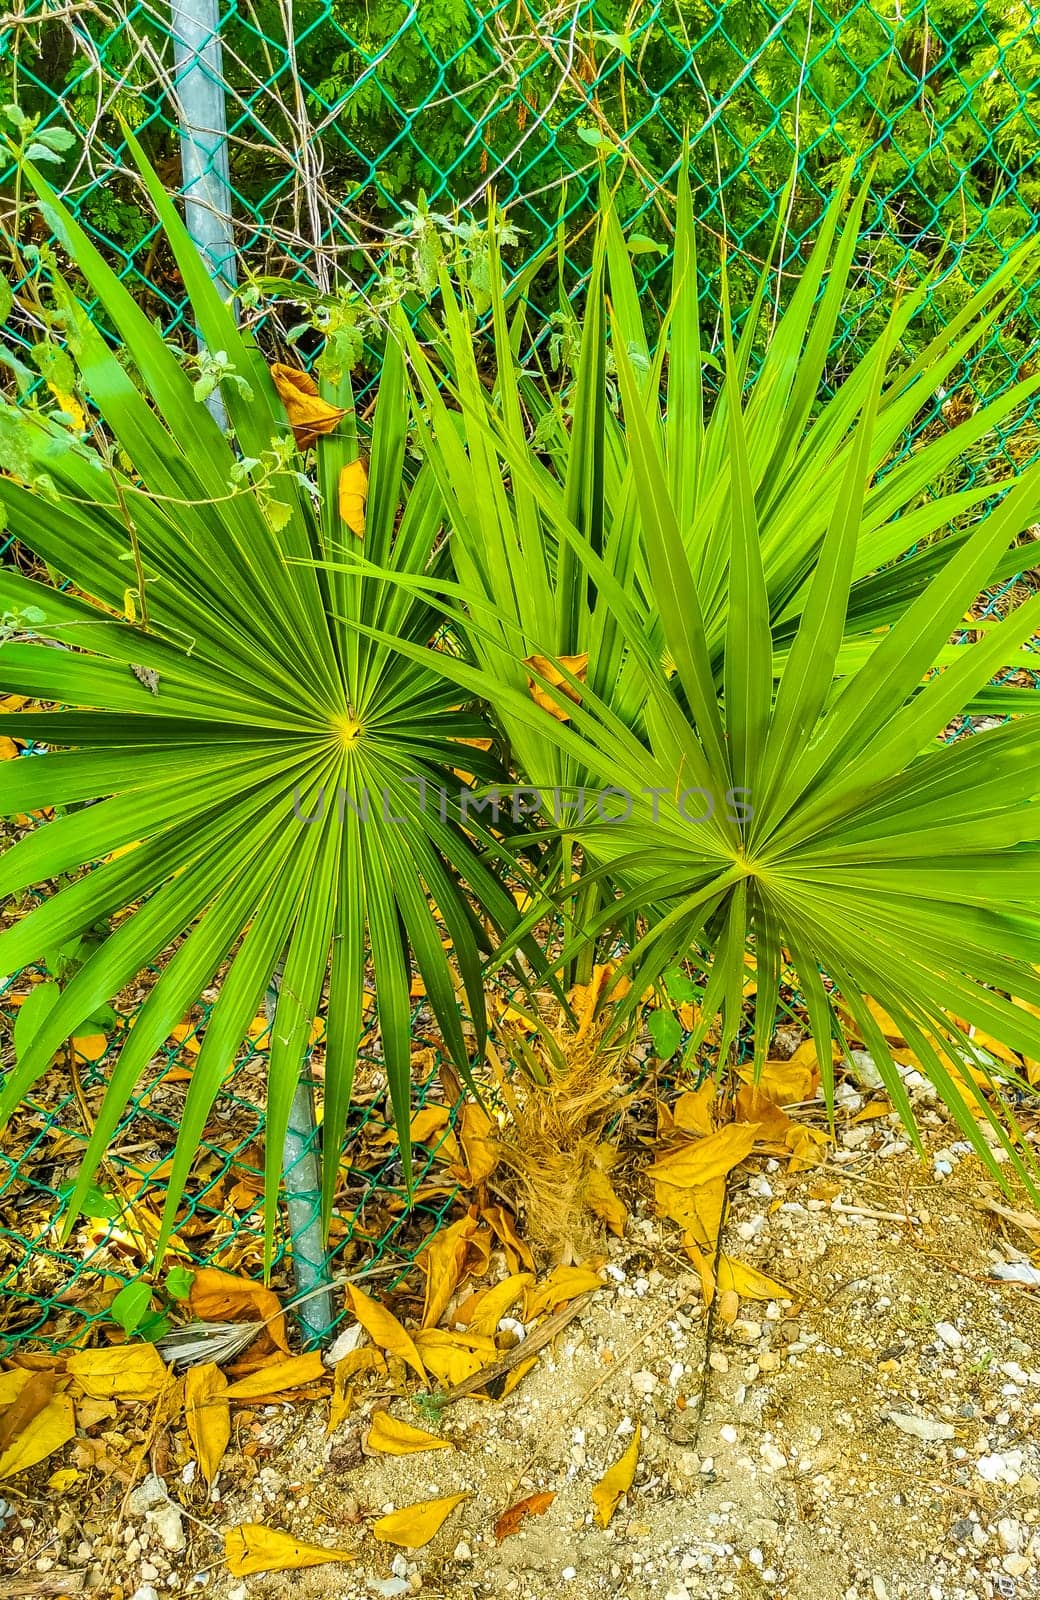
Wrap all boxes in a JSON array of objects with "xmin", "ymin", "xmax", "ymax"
[{"xmin": 0, "ymin": 137, "xmax": 515, "ymax": 1240}]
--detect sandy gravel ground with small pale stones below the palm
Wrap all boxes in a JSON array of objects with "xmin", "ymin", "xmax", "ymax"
[{"xmin": 3, "ymin": 1107, "xmax": 1040, "ymax": 1600}]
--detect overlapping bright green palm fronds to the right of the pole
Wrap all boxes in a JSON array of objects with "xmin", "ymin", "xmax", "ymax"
[{"xmin": 353, "ymin": 182, "xmax": 1040, "ymax": 1190}]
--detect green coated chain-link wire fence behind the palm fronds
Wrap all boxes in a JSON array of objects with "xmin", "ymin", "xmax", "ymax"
[{"xmin": 0, "ymin": 0, "xmax": 1040, "ymax": 1349}]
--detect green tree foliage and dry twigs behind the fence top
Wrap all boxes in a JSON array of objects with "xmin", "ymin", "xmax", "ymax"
[{"xmin": 0, "ymin": 0, "xmax": 1040, "ymax": 412}]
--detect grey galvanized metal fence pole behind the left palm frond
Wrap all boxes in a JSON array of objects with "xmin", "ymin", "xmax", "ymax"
[{"xmin": 171, "ymin": 0, "xmax": 333, "ymax": 1344}]
